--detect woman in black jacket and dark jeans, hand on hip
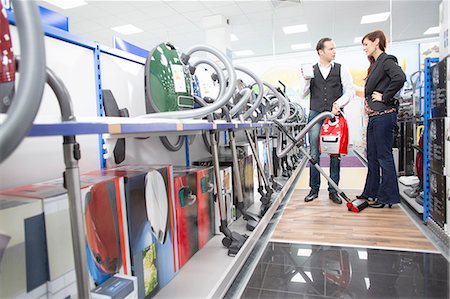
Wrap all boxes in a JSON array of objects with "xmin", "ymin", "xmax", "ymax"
[{"xmin": 357, "ymin": 30, "xmax": 406, "ymax": 208}]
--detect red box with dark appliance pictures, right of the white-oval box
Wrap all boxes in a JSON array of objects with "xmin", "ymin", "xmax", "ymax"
[{"xmin": 174, "ymin": 166, "xmax": 215, "ymax": 267}]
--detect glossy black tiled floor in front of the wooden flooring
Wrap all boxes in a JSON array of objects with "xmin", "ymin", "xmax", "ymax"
[{"xmin": 241, "ymin": 242, "xmax": 450, "ymax": 298}]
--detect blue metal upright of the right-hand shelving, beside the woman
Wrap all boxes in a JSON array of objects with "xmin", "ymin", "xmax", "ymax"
[{"xmin": 422, "ymin": 58, "xmax": 439, "ymax": 223}]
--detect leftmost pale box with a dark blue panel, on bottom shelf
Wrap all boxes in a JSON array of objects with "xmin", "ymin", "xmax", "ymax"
[{"xmin": 0, "ymin": 195, "xmax": 49, "ymax": 298}]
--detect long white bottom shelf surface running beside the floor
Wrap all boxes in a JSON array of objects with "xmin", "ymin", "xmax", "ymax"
[{"xmin": 156, "ymin": 161, "xmax": 306, "ymax": 298}]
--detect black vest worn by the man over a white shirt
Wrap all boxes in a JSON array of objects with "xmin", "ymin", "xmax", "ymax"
[{"xmin": 309, "ymin": 63, "xmax": 343, "ymax": 112}]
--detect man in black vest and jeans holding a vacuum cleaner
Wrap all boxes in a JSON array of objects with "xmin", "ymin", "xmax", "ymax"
[{"xmin": 302, "ymin": 37, "xmax": 355, "ymax": 204}]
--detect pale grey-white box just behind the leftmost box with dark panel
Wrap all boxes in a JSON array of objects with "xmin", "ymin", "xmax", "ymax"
[{"xmin": 0, "ymin": 179, "xmax": 76, "ymax": 295}]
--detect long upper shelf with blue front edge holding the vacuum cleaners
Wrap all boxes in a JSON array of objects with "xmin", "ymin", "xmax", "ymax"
[{"xmin": 14, "ymin": 117, "xmax": 272, "ymax": 137}]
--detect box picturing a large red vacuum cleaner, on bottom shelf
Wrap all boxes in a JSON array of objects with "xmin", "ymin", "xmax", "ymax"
[{"xmin": 80, "ymin": 173, "xmax": 131, "ymax": 289}]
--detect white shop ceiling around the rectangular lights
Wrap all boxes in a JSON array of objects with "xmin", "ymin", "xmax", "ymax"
[{"xmin": 38, "ymin": 0, "xmax": 441, "ymax": 55}]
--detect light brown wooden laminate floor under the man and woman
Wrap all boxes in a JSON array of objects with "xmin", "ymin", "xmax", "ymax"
[{"xmin": 272, "ymin": 168, "xmax": 438, "ymax": 252}]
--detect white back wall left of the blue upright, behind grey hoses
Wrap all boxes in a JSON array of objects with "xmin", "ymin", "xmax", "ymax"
[{"xmin": 0, "ymin": 26, "xmax": 100, "ymax": 188}]
